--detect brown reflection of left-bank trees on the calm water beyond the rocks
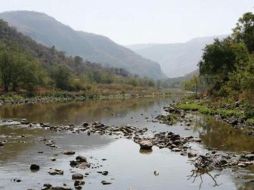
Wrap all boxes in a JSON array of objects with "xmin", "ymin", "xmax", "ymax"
[{"xmin": 0, "ymin": 98, "xmax": 165, "ymax": 124}]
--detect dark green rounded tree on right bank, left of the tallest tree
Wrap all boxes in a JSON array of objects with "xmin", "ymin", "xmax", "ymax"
[{"xmin": 199, "ymin": 38, "xmax": 249, "ymax": 93}]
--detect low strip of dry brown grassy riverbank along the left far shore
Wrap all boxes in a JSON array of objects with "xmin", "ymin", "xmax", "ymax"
[{"xmin": 0, "ymin": 85, "xmax": 171, "ymax": 105}]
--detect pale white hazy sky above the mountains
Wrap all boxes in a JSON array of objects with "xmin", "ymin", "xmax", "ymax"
[{"xmin": 0, "ymin": 0, "xmax": 254, "ymax": 45}]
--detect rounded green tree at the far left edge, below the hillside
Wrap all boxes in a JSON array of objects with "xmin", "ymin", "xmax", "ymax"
[{"xmin": 0, "ymin": 48, "xmax": 47, "ymax": 92}]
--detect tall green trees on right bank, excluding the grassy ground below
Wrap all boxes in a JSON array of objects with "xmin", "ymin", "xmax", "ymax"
[{"xmin": 199, "ymin": 13, "xmax": 254, "ymax": 99}]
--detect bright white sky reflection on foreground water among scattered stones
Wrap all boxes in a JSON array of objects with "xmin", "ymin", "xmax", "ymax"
[{"xmin": 0, "ymin": 138, "xmax": 238, "ymax": 190}]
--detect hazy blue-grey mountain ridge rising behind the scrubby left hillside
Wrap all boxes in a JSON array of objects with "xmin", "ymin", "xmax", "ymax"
[{"xmin": 0, "ymin": 11, "xmax": 166, "ymax": 79}]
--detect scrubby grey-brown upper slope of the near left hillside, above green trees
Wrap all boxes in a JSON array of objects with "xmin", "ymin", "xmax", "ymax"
[{"xmin": 0, "ymin": 19, "xmax": 131, "ymax": 77}]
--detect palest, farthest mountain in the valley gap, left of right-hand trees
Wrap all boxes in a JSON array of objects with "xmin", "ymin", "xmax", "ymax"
[{"xmin": 128, "ymin": 35, "xmax": 226, "ymax": 78}]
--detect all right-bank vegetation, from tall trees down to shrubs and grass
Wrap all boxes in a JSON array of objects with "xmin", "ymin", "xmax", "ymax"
[{"xmin": 178, "ymin": 12, "xmax": 254, "ymax": 126}]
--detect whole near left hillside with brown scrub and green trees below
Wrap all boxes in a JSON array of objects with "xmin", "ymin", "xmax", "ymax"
[{"xmin": 0, "ymin": 20, "xmax": 160, "ymax": 95}]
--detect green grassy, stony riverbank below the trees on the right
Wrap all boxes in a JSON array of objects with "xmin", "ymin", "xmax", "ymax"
[{"xmin": 159, "ymin": 97, "xmax": 254, "ymax": 135}]
